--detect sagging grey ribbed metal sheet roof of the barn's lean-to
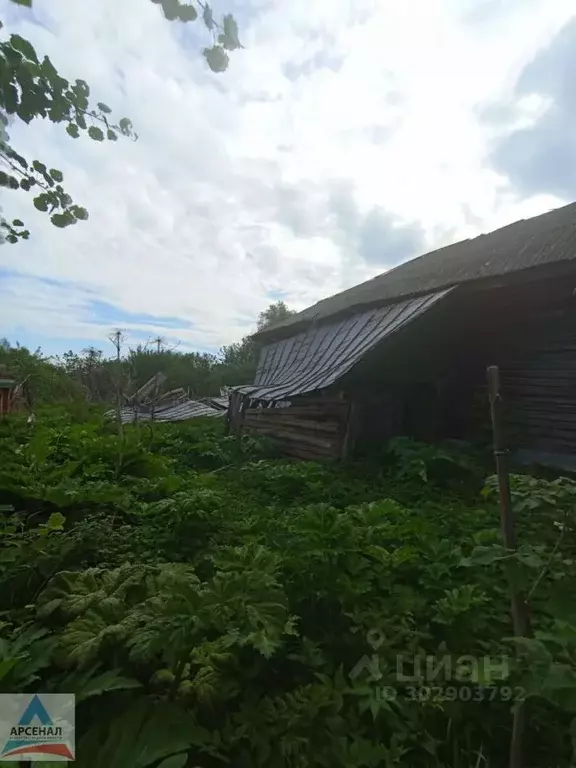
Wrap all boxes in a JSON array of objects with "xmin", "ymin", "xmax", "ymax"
[{"xmin": 238, "ymin": 289, "xmax": 451, "ymax": 400}]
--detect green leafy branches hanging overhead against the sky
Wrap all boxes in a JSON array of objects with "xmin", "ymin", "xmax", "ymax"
[{"xmin": 0, "ymin": 0, "xmax": 242, "ymax": 243}]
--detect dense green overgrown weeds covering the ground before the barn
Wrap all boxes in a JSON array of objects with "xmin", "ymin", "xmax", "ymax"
[{"xmin": 0, "ymin": 408, "xmax": 576, "ymax": 768}]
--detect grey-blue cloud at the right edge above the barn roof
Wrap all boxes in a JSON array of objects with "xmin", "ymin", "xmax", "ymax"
[{"xmin": 489, "ymin": 19, "xmax": 576, "ymax": 200}]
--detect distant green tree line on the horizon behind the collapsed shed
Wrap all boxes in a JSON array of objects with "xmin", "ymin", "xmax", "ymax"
[{"xmin": 0, "ymin": 301, "xmax": 294, "ymax": 406}]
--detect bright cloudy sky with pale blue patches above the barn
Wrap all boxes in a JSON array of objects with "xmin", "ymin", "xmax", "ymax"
[{"xmin": 0, "ymin": 0, "xmax": 576, "ymax": 354}]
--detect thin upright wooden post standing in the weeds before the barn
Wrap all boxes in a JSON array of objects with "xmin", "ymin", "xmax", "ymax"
[{"xmin": 487, "ymin": 365, "xmax": 530, "ymax": 768}]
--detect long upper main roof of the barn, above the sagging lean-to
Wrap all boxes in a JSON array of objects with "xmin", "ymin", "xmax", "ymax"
[{"xmin": 255, "ymin": 203, "xmax": 576, "ymax": 343}]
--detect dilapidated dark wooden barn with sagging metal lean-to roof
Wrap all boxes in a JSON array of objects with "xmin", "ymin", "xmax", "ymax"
[{"xmin": 229, "ymin": 203, "xmax": 576, "ymax": 468}]
